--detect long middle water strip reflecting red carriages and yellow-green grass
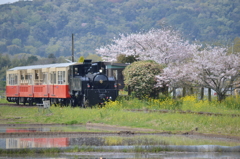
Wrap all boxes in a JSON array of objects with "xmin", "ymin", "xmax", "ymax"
[{"xmin": 0, "ymin": 135, "xmax": 240, "ymax": 149}]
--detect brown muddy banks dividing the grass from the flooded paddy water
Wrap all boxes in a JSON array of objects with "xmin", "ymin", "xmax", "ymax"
[{"xmin": 0, "ymin": 123, "xmax": 240, "ymax": 143}]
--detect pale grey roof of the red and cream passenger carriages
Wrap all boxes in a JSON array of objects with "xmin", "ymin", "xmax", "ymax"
[{"xmin": 8, "ymin": 62, "xmax": 75, "ymax": 71}]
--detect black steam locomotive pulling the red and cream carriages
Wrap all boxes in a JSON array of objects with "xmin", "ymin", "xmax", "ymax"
[{"xmin": 69, "ymin": 60, "xmax": 118, "ymax": 107}]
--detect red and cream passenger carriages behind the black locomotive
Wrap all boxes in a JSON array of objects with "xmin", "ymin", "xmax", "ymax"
[{"xmin": 6, "ymin": 63, "xmax": 74, "ymax": 105}]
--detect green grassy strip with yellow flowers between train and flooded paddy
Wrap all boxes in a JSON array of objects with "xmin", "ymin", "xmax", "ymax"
[{"xmin": 0, "ymin": 96, "xmax": 240, "ymax": 136}]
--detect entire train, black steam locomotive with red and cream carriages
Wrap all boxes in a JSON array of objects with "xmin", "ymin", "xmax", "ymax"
[{"xmin": 6, "ymin": 59, "xmax": 127, "ymax": 107}]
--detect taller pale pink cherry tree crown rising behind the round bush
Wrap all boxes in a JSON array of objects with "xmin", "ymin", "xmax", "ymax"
[{"xmin": 96, "ymin": 29, "xmax": 199, "ymax": 64}]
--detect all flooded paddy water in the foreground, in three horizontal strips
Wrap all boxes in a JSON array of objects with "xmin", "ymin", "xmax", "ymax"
[{"xmin": 0, "ymin": 126, "xmax": 240, "ymax": 159}]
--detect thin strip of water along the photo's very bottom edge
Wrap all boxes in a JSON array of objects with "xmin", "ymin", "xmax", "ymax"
[{"xmin": 0, "ymin": 152, "xmax": 240, "ymax": 159}]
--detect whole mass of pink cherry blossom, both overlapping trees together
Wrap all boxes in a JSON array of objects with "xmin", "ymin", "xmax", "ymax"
[{"xmin": 96, "ymin": 29, "xmax": 240, "ymax": 101}]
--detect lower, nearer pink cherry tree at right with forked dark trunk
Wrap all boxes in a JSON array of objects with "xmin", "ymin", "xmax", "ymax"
[{"xmin": 158, "ymin": 47, "xmax": 240, "ymax": 101}]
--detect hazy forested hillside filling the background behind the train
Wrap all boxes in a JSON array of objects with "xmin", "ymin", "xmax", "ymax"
[{"xmin": 0, "ymin": 0, "xmax": 240, "ymax": 57}]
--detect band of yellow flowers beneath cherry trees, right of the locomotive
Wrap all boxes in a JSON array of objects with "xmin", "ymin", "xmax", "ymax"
[{"xmin": 105, "ymin": 96, "xmax": 240, "ymax": 115}]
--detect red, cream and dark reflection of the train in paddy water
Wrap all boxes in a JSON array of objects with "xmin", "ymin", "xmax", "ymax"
[{"xmin": 0, "ymin": 128, "xmax": 109, "ymax": 149}]
